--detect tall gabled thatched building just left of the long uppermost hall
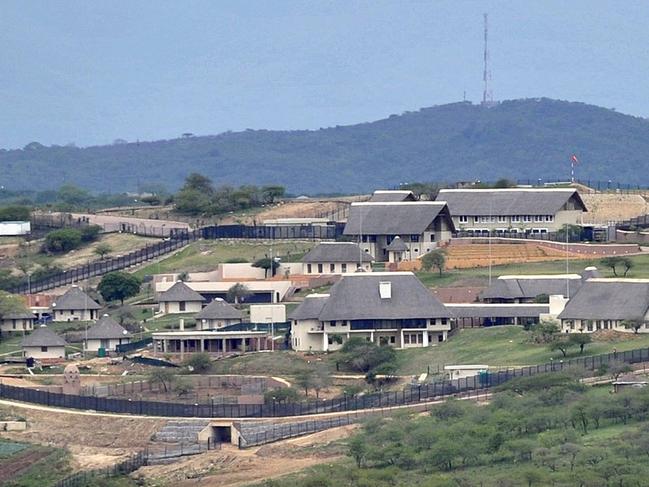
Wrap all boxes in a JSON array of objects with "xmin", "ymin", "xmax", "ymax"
[{"xmin": 343, "ymin": 201, "xmax": 455, "ymax": 262}]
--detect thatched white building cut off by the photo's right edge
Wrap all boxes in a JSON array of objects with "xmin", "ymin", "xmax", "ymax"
[{"xmin": 558, "ymin": 278, "xmax": 649, "ymax": 333}]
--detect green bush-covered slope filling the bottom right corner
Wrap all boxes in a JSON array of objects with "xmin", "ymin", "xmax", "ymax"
[{"xmin": 264, "ymin": 370, "xmax": 649, "ymax": 487}]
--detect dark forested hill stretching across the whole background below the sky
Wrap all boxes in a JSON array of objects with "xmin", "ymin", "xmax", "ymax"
[{"xmin": 0, "ymin": 99, "xmax": 649, "ymax": 194}]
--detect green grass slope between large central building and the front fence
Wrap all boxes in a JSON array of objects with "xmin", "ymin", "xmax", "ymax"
[{"xmin": 397, "ymin": 325, "xmax": 649, "ymax": 375}]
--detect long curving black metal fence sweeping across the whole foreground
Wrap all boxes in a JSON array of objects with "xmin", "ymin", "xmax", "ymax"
[{"xmin": 5, "ymin": 348, "xmax": 649, "ymax": 418}]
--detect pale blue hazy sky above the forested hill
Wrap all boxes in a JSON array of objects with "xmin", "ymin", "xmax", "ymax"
[{"xmin": 0, "ymin": 0, "xmax": 649, "ymax": 148}]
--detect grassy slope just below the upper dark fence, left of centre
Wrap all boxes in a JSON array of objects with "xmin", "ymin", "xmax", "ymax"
[{"xmin": 135, "ymin": 240, "xmax": 315, "ymax": 277}]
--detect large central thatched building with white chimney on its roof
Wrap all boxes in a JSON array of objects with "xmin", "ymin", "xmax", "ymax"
[{"xmin": 289, "ymin": 272, "xmax": 452, "ymax": 351}]
